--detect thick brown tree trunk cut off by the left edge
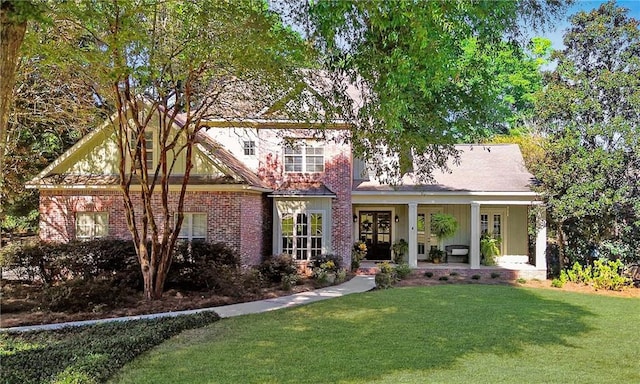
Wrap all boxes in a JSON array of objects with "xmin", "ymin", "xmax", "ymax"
[{"xmin": 0, "ymin": 1, "xmax": 27, "ymax": 248}]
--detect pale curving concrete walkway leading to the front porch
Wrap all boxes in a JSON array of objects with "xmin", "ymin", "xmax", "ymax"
[{"xmin": 0, "ymin": 276, "xmax": 375, "ymax": 332}]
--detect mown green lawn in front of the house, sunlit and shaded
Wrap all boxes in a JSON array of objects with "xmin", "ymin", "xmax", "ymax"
[{"xmin": 112, "ymin": 285, "xmax": 640, "ymax": 383}]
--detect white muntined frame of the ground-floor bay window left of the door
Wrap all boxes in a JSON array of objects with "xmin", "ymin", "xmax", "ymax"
[{"xmin": 279, "ymin": 210, "xmax": 328, "ymax": 261}]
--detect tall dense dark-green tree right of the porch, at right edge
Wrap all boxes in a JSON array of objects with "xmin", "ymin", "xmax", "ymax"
[{"xmin": 535, "ymin": 2, "xmax": 640, "ymax": 263}]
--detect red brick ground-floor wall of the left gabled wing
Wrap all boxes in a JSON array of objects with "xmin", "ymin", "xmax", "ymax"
[{"xmin": 40, "ymin": 190, "xmax": 266, "ymax": 264}]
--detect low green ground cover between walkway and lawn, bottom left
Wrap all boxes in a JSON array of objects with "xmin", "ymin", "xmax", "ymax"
[{"xmin": 0, "ymin": 312, "xmax": 219, "ymax": 384}]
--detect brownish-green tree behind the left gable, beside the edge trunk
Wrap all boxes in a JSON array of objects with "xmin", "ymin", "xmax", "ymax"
[{"xmin": 0, "ymin": 27, "xmax": 101, "ymax": 233}]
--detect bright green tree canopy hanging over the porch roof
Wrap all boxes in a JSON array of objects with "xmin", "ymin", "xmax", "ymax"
[{"xmin": 292, "ymin": 0, "xmax": 564, "ymax": 181}]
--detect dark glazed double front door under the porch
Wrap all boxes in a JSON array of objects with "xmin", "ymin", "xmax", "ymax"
[{"xmin": 360, "ymin": 211, "xmax": 391, "ymax": 260}]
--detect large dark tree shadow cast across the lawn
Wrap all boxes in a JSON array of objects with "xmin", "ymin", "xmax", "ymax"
[{"xmin": 228, "ymin": 285, "xmax": 593, "ymax": 382}]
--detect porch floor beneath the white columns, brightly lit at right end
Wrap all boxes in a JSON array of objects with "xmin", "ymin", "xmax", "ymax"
[{"xmin": 357, "ymin": 260, "xmax": 547, "ymax": 280}]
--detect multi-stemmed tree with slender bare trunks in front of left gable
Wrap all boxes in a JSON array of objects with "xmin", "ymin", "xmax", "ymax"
[{"xmin": 44, "ymin": 0, "xmax": 305, "ymax": 299}]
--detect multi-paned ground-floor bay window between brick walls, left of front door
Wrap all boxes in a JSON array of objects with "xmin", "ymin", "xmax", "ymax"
[{"xmin": 281, "ymin": 212, "xmax": 324, "ymax": 260}]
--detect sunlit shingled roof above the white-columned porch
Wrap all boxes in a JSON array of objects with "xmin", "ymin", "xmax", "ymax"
[{"xmin": 353, "ymin": 144, "xmax": 535, "ymax": 193}]
